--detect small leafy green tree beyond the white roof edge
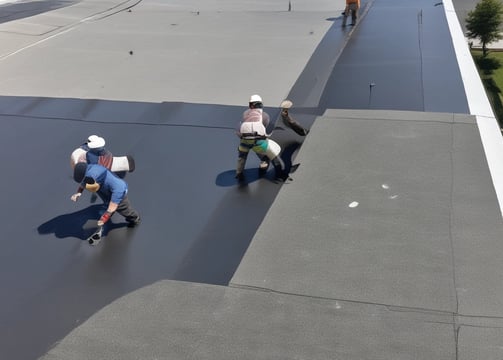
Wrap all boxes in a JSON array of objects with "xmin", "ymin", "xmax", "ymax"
[{"xmin": 465, "ymin": 0, "xmax": 503, "ymax": 57}]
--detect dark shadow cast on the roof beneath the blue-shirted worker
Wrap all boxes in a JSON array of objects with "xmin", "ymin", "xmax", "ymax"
[{"xmin": 37, "ymin": 204, "xmax": 127, "ymax": 240}]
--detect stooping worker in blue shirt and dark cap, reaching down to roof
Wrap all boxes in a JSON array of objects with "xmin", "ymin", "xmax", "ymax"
[{"xmin": 71, "ymin": 162, "xmax": 140, "ymax": 227}]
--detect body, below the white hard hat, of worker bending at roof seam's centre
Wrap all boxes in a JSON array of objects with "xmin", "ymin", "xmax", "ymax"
[{"xmin": 236, "ymin": 99, "xmax": 288, "ymax": 181}]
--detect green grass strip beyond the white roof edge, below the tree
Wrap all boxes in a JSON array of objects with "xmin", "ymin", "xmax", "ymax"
[{"xmin": 472, "ymin": 49, "xmax": 503, "ymax": 128}]
